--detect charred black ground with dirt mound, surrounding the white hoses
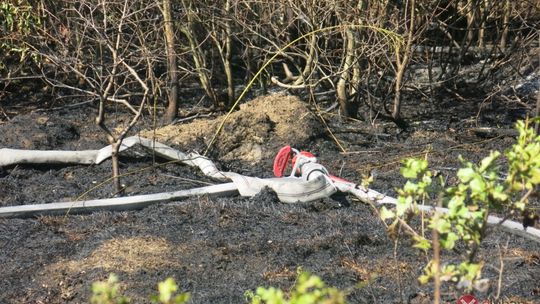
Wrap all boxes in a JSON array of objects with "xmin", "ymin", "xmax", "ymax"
[{"xmin": 0, "ymin": 86, "xmax": 540, "ymax": 303}]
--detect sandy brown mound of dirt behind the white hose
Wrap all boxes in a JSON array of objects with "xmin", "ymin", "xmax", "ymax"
[{"xmin": 141, "ymin": 94, "xmax": 324, "ymax": 165}]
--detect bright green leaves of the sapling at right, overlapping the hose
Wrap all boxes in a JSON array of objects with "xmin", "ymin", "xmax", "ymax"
[{"xmin": 380, "ymin": 121, "xmax": 540, "ymax": 288}]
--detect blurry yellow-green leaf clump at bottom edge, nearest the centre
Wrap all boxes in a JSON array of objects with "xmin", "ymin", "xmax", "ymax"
[{"xmin": 245, "ymin": 272, "xmax": 345, "ymax": 304}]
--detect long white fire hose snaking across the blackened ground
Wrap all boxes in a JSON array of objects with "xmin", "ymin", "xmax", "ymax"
[{"xmin": 0, "ymin": 136, "xmax": 540, "ymax": 243}]
